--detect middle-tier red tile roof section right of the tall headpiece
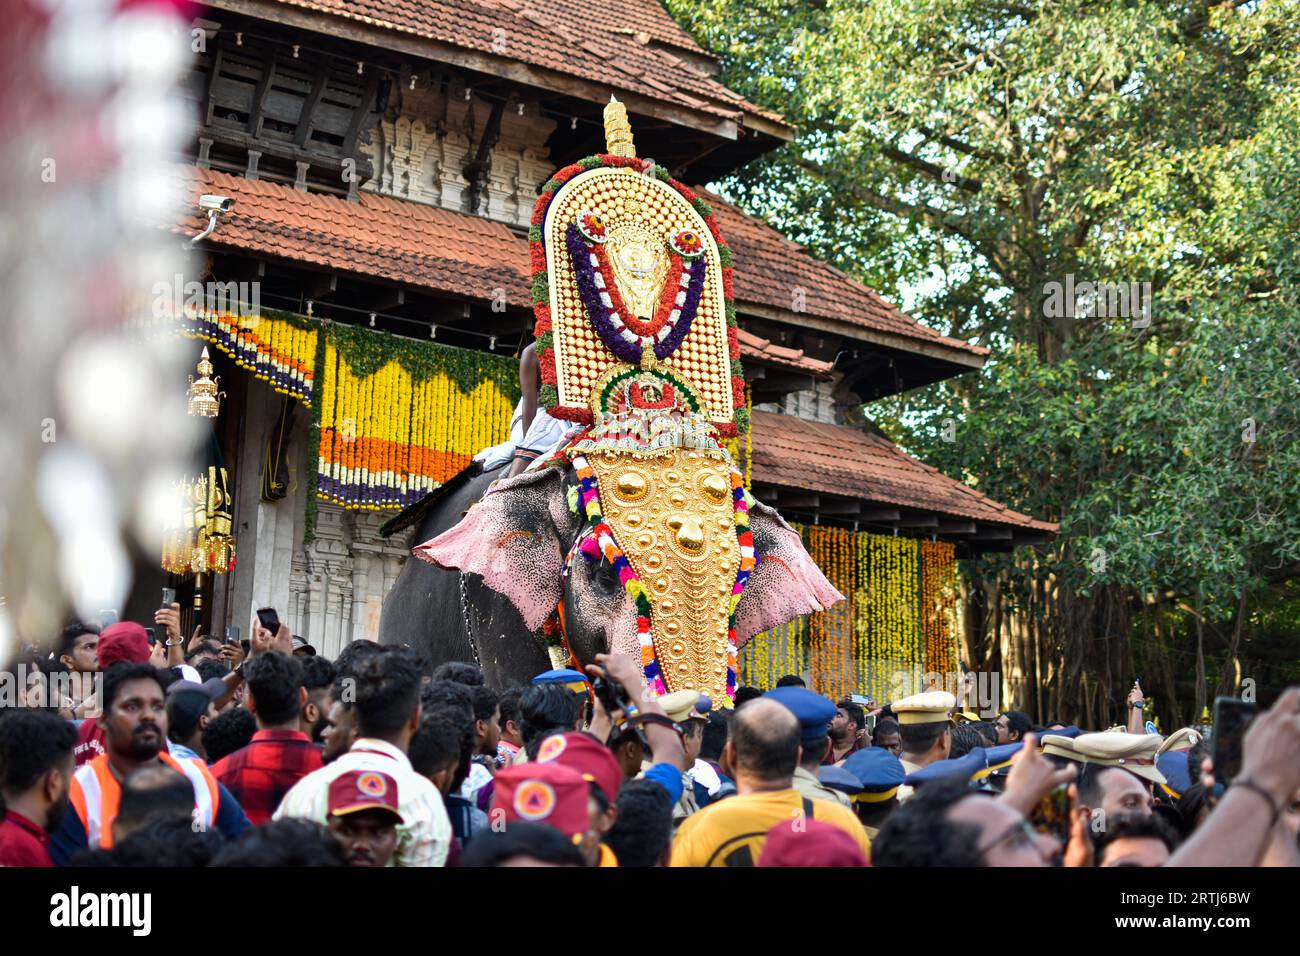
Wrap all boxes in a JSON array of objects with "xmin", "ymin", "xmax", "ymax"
[{"xmin": 696, "ymin": 187, "xmax": 989, "ymax": 356}]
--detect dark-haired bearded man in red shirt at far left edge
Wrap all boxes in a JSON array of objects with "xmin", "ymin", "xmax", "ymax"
[{"xmin": 0, "ymin": 710, "xmax": 77, "ymax": 866}]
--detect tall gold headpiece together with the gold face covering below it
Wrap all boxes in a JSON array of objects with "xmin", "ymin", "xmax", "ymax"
[{"xmin": 529, "ymin": 98, "xmax": 757, "ymax": 706}]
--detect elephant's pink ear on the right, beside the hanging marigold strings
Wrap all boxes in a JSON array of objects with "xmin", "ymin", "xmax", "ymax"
[{"xmin": 736, "ymin": 501, "xmax": 844, "ymax": 645}]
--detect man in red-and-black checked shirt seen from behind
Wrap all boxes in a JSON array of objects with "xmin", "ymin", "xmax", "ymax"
[{"xmin": 212, "ymin": 650, "xmax": 324, "ymax": 826}]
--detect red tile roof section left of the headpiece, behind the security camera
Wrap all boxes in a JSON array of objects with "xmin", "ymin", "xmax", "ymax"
[{"xmin": 161, "ymin": 166, "xmax": 532, "ymax": 307}]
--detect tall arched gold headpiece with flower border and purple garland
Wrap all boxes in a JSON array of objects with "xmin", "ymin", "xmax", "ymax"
[{"xmin": 529, "ymin": 98, "xmax": 745, "ymax": 437}]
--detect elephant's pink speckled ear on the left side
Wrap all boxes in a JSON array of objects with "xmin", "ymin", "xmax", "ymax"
[{"xmin": 412, "ymin": 468, "xmax": 577, "ymax": 631}]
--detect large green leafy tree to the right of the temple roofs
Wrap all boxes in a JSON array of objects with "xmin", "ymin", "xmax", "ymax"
[{"xmin": 667, "ymin": 0, "xmax": 1300, "ymax": 726}]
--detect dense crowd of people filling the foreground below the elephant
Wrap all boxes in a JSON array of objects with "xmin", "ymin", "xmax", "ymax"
[{"xmin": 0, "ymin": 605, "xmax": 1300, "ymax": 868}]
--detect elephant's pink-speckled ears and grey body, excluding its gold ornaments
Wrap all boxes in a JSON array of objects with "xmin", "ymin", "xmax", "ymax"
[{"xmin": 380, "ymin": 457, "xmax": 841, "ymax": 700}]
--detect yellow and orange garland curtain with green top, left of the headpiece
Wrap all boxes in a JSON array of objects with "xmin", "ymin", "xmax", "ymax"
[{"xmin": 166, "ymin": 308, "xmax": 519, "ymax": 515}]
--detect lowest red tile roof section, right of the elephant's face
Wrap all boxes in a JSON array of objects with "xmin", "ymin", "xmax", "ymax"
[{"xmin": 753, "ymin": 411, "xmax": 1060, "ymax": 533}]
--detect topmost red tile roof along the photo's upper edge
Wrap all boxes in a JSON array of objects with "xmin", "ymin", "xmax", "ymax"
[{"xmin": 269, "ymin": 0, "xmax": 790, "ymax": 129}]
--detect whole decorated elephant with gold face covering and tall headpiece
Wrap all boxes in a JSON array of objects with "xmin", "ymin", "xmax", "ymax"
[{"xmin": 381, "ymin": 100, "xmax": 842, "ymax": 706}]
